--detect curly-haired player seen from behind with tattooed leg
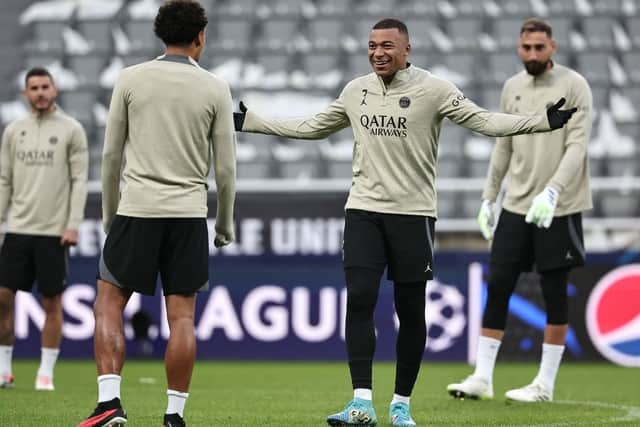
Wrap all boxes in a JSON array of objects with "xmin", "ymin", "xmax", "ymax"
[{"xmin": 75, "ymin": 0, "xmax": 236, "ymax": 427}]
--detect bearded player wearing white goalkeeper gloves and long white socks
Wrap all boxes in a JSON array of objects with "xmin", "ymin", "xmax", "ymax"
[{"xmin": 447, "ymin": 18, "xmax": 592, "ymax": 402}]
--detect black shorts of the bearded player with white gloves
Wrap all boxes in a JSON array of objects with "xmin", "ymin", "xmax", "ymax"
[{"xmin": 490, "ymin": 209, "xmax": 585, "ymax": 272}]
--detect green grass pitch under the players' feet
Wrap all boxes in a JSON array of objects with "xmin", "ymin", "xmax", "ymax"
[{"xmin": 0, "ymin": 360, "xmax": 640, "ymax": 427}]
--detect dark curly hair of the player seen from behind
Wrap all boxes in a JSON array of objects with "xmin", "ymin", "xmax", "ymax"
[{"xmin": 153, "ymin": 0, "xmax": 209, "ymax": 46}]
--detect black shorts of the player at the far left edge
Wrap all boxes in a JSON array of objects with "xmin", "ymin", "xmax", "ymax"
[{"xmin": 0, "ymin": 233, "xmax": 67, "ymax": 297}]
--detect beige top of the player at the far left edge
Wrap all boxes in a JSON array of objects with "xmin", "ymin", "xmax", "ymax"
[{"xmin": 0, "ymin": 108, "xmax": 89, "ymax": 236}]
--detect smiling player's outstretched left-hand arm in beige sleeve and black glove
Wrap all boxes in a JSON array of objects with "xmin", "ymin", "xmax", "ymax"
[{"xmin": 233, "ymin": 98, "xmax": 349, "ymax": 139}]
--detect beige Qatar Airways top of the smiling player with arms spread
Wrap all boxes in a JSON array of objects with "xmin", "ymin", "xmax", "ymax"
[{"xmin": 242, "ymin": 65, "xmax": 550, "ymax": 217}]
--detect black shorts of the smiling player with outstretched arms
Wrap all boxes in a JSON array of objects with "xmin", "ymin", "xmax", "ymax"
[{"xmin": 343, "ymin": 209, "xmax": 435, "ymax": 282}]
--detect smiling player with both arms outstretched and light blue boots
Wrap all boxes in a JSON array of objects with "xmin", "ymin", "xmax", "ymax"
[{"xmin": 234, "ymin": 18, "xmax": 574, "ymax": 426}]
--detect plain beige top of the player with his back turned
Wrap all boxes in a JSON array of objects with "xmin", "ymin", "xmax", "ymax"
[{"xmin": 102, "ymin": 55, "xmax": 236, "ymax": 241}]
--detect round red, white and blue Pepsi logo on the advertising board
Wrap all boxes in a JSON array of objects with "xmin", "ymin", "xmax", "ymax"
[{"xmin": 586, "ymin": 264, "xmax": 640, "ymax": 366}]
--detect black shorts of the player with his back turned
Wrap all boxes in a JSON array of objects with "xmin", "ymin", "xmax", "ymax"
[{"xmin": 98, "ymin": 215, "xmax": 209, "ymax": 295}]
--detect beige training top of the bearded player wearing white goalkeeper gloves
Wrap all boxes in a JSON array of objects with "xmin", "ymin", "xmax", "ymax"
[{"xmin": 482, "ymin": 64, "xmax": 593, "ymax": 216}]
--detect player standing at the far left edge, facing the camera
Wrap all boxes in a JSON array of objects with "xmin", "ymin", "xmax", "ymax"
[{"xmin": 0, "ymin": 67, "xmax": 89, "ymax": 391}]
